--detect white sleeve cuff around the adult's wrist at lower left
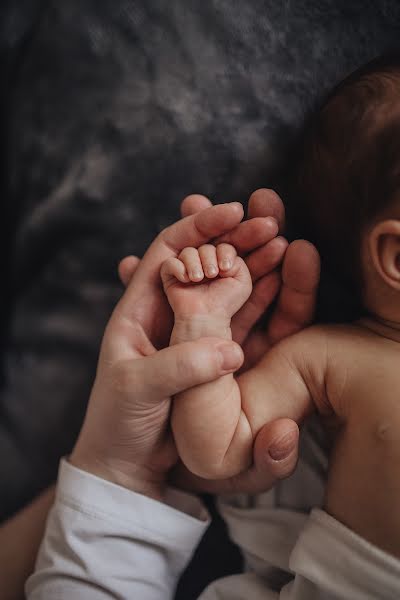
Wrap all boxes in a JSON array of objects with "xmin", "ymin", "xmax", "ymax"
[{"xmin": 26, "ymin": 460, "xmax": 209, "ymax": 600}]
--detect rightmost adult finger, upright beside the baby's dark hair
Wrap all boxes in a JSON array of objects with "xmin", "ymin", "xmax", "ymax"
[{"xmin": 268, "ymin": 240, "xmax": 320, "ymax": 344}]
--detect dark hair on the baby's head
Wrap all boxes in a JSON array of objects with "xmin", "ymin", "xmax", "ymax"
[{"xmin": 290, "ymin": 53, "xmax": 400, "ymax": 303}]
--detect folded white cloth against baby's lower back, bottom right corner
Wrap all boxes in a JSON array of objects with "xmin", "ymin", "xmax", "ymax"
[{"xmin": 280, "ymin": 509, "xmax": 400, "ymax": 600}]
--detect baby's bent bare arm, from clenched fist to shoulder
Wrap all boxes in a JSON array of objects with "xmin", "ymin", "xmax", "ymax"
[{"xmin": 162, "ymin": 244, "xmax": 324, "ymax": 479}]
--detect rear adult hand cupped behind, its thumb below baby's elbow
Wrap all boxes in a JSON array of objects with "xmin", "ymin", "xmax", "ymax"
[{"xmin": 119, "ymin": 189, "xmax": 319, "ymax": 493}]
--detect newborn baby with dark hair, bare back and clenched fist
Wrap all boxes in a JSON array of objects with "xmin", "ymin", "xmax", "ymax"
[{"xmin": 163, "ymin": 53, "xmax": 400, "ymax": 556}]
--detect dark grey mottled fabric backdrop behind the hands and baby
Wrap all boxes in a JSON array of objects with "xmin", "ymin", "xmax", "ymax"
[{"xmin": 0, "ymin": 0, "xmax": 400, "ymax": 597}]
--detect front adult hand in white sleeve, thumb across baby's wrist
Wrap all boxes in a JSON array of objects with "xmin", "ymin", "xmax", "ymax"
[{"xmin": 70, "ymin": 203, "xmax": 260, "ymax": 497}]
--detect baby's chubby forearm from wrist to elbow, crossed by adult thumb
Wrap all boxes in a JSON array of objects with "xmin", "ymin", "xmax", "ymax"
[{"xmin": 171, "ymin": 316, "xmax": 252, "ymax": 479}]
